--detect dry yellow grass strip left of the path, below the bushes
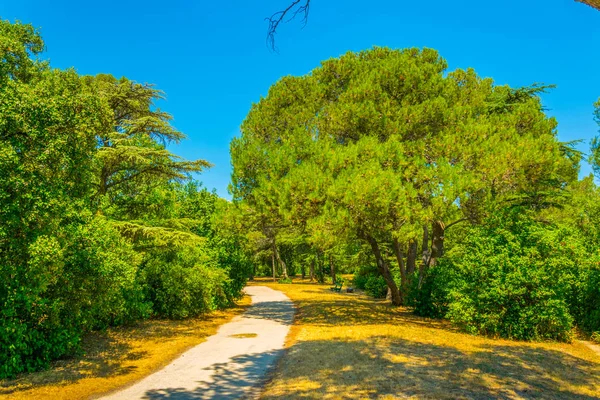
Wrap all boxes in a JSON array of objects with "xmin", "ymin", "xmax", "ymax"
[{"xmin": 0, "ymin": 296, "xmax": 251, "ymax": 400}]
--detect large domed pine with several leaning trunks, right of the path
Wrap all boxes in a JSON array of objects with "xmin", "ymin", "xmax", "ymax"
[{"xmin": 232, "ymin": 48, "xmax": 577, "ymax": 304}]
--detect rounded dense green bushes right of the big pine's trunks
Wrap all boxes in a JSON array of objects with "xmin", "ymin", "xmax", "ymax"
[{"xmin": 411, "ymin": 215, "xmax": 600, "ymax": 340}]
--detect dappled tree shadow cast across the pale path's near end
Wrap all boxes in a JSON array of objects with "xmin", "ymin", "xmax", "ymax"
[{"xmin": 143, "ymin": 350, "xmax": 283, "ymax": 400}]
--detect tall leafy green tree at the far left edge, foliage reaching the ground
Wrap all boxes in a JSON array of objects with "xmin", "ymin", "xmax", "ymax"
[{"xmin": 0, "ymin": 21, "xmax": 139, "ymax": 377}]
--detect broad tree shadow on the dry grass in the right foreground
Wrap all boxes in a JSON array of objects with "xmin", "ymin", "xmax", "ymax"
[{"xmin": 263, "ymin": 337, "xmax": 600, "ymax": 400}]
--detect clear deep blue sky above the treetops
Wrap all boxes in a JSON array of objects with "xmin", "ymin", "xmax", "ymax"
[{"xmin": 0, "ymin": 0, "xmax": 600, "ymax": 198}]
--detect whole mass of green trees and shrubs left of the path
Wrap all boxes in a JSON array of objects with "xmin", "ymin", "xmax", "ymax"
[{"xmin": 0, "ymin": 21, "xmax": 251, "ymax": 378}]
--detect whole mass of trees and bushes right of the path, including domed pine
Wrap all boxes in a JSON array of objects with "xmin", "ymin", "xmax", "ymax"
[{"xmin": 231, "ymin": 48, "xmax": 600, "ymax": 340}]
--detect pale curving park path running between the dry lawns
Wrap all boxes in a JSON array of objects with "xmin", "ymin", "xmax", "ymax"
[{"xmin": 102, "ymin": 286, "xmax": 294, "ymax": 400}]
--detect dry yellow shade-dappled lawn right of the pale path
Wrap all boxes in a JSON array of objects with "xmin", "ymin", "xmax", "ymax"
[{"xmin": 255, "ymin": 280, "xmax": 600, "ymax": 400}]
